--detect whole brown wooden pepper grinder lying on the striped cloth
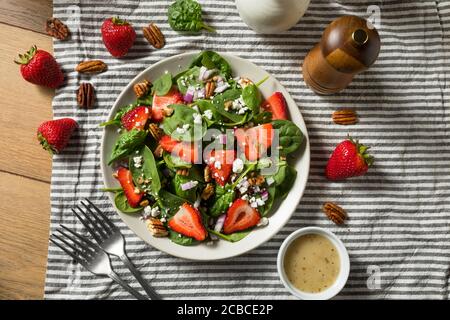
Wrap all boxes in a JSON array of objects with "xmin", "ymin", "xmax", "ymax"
[{"xmin": 302, "ymin": 16, "xmax": 380, "ymax": 94}]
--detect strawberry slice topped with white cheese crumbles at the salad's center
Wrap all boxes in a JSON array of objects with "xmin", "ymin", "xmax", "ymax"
[{"xmin": 205, "ymin": 150, "xmax": 236, "ymax": 186}]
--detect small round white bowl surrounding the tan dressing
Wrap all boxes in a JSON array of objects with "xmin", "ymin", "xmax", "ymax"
[{"xmin": 277, "ymin": 227, "xmax": 350, "ymax": 300}]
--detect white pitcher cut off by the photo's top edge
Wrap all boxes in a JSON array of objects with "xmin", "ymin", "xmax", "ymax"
[{"xmin": 236, "ymin": 0, "xmax": 310, "ymax": 33}]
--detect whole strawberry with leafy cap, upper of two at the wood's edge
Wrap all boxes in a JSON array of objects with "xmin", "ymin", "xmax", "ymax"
[{"xmin": 14, "ymin": 46, "xmax": 64, "ymax": 89}]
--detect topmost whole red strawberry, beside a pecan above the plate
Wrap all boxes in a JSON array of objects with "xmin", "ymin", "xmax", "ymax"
[{"xmin": 101, "ymin": 17, "xmax": 136, "ymax": 58}]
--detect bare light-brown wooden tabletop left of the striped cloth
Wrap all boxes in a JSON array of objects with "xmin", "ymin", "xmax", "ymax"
[{"xmin": 0, "ymin": 0, "xmax": 54, "ymax": 299}]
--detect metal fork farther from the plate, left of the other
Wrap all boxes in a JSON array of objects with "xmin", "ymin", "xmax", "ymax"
[{"xmin": 50, "ymin": 225, "xmax": 148, "ymax": 300}]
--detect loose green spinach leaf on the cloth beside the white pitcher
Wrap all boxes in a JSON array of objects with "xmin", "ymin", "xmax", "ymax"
[{"xmin": 167, "ymin": 0, "xmax": 215, "ymax": 32}]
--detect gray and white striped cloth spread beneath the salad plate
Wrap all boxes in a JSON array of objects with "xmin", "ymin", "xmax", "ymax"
[{"xmin": 45, "ymin": 0, "xmax": 450, "ymax": 299}]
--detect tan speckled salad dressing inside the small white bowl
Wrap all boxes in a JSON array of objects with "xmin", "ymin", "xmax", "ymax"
[{"xmin": 284, "ymin": 234, "xmax": 340, "ymax": 293}]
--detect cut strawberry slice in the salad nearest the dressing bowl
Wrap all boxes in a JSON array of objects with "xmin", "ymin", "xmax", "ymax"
[{"xmin": 223, "ymin": 198, "xmax": 261, "ymax": 234}]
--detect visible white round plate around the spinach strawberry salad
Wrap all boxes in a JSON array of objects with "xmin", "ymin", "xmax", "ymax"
[{"xmin": 101, "ymin": 52, "xmax": 310, "ymax": 261}]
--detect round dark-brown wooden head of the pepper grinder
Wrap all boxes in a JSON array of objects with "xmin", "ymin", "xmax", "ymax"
[{"xmin": 320, "ymin": 16, "xmax": 380, "ymax": 74}]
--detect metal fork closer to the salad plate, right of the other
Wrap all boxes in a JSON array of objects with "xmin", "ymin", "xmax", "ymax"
[{"xmin": 72, "ymin": 199, "xmax": 161, "ymax": 300}]
